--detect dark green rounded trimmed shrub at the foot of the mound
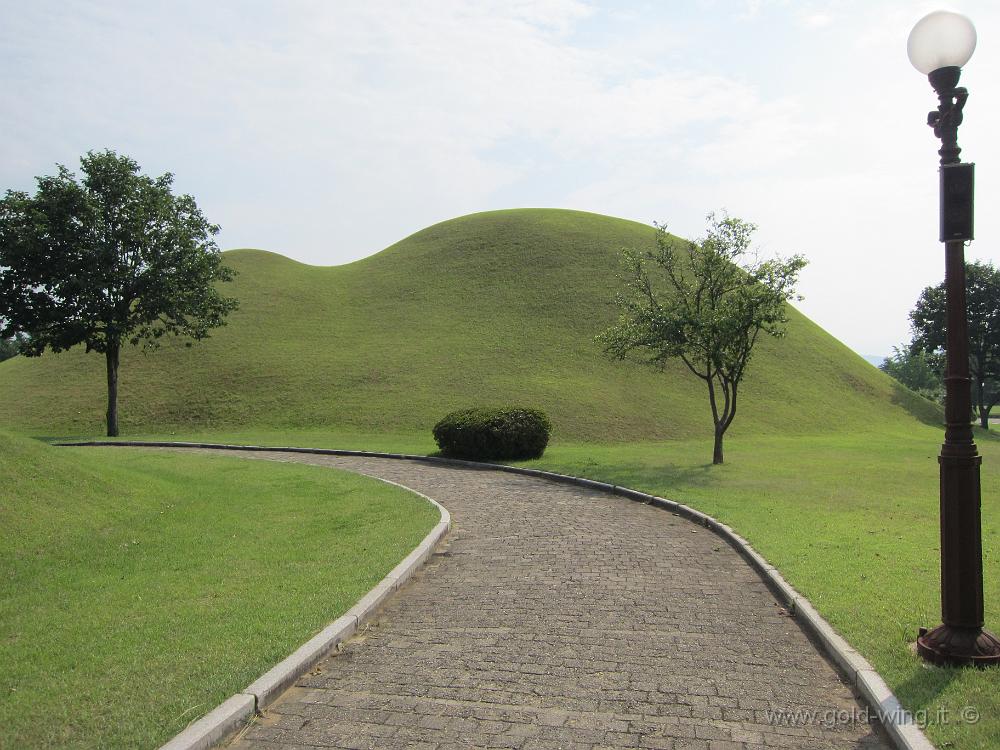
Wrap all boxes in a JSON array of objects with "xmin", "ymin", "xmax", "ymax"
[{"xmin": 434, "ymin": 407, "xmax": 552, "ymax": 461}]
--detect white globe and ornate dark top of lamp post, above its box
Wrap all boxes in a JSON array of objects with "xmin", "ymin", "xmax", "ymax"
[{"xmin": 906, "ymin": 10, "xmax": 976, "ymax": 164}]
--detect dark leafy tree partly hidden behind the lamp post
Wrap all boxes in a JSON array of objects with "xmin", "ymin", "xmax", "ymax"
[{"xmin": 910, "ymin": 262, "xmax": 1000, "ymax": 430}]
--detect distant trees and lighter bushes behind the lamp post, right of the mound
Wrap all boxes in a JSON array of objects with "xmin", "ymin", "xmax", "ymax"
[{"xmin": 880, "ymin": 261, "xmax": 1000, "ymax": 430}]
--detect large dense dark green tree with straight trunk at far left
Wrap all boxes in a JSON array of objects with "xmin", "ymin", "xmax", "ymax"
[{"xmin": 0, "ymin": 151, "xmax": 237, "ymax": 437}]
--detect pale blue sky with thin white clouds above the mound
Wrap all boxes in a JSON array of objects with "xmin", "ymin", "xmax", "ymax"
[{"xmin": 0, "ymin": 0, "xmax": 1000, "ymax": 355}]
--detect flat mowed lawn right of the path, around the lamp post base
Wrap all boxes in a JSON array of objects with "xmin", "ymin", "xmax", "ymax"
[{"xmin": 526, "ymin": 426, "xmax": 1000, "ymax": 750}]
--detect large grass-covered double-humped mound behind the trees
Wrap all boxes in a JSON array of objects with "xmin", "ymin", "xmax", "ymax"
[{"xmin": 0, "ymin": 209, "xmax": 938, "ymax": 441}]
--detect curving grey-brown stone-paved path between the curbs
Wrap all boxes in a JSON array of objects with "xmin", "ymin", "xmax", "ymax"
[{"xmin": 205, "ymin": 454, "xmax": 885, "ymax": 750}]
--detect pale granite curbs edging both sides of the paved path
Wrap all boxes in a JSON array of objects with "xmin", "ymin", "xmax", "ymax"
[{"xmin": 57, "ymin": 440, "xmax": 934, "ymax": 750}]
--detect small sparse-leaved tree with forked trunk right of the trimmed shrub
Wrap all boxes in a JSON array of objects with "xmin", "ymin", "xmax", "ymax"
[{"xmin": 598, "ymin": 214, "xmax": 806, "ymax": 464}]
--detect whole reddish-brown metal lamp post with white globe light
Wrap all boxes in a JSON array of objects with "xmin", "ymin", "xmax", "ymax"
[{"xmin": 907, "ymin": 11, "xmax": 1000, "ymax": 666}]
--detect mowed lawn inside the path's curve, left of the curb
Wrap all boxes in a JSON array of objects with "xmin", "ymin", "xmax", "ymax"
[{"xmin": 0, "ymin": 433, "xmax": 438, "ymax": 749}]
